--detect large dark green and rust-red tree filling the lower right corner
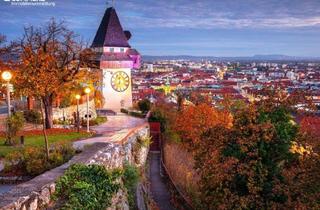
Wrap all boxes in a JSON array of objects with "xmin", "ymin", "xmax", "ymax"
[{"xmin": 195, "ymin": 103, "xmax": 319, "ymax": 209}]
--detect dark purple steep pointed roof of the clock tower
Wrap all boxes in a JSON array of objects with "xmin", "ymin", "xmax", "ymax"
[{"xmin": 91, "ymin": 7, "xmax": 130, "ymax": 47}]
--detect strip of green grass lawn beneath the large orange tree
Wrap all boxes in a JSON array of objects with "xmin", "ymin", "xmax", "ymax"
[{"xmin": 0, "ymin": 132, "xmax": 92, "ymax": 158}]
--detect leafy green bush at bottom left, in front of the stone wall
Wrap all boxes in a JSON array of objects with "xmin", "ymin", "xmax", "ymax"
[{"xmin": 55, "ymin": 164, "xmax": 121, "ymax": 210}]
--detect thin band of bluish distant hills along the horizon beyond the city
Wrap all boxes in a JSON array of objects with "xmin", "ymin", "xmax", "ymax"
[{"xmin": 142, "ymin": 55, "xmax": 320, "ymax": 61}]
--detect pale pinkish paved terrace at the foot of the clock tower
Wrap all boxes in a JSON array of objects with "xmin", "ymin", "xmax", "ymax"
[{"xmin": 73, "ymin": 115, "xmax": 146, "ymax": 150}]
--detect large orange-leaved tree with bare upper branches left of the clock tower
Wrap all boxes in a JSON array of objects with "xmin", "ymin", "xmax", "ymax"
[{"xmin": 14, "ymin": 19, "xmax": 92, "ymax": 128}]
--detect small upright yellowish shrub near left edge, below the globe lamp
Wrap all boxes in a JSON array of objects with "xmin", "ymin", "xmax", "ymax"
[{"xmin": 6, "ymin": 112, "xmax": 25, "ymax": 145}]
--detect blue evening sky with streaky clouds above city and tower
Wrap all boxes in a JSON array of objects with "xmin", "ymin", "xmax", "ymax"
[{"xmin": 0, "ymin": 0, "xmax": 320, "ymax": 57}]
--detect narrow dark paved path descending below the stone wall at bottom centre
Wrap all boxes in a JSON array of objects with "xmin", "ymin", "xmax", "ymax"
[{"xmin": 149, "ymin": 152, "xmax": 175, "ymax": 210}]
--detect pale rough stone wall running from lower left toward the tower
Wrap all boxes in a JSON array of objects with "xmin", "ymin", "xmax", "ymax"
[{"xmin": 0, "ymin": 123, "xmax": 150, "ymax": 210}]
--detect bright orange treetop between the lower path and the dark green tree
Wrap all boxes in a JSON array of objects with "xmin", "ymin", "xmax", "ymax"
[{"xmin": 174, "ymin": 103, "xmax": 232, "ymax": 143}]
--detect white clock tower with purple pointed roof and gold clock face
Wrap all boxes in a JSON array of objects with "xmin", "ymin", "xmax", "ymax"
[{"xmin": 91, "ymin": 7, "xmax": 141, "ymax": 112}]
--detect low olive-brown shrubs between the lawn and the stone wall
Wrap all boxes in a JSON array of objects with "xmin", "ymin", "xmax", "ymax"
[{"xmin": 4, "ymin": 143, "xmax": 75, "ymax": 176}]
